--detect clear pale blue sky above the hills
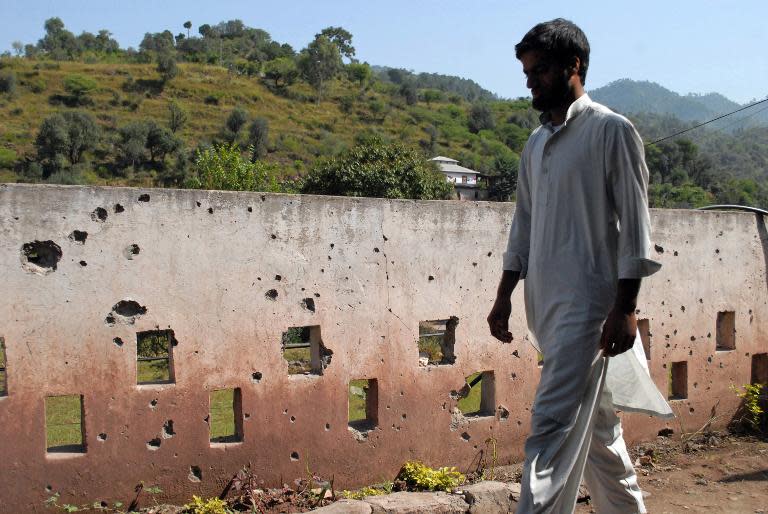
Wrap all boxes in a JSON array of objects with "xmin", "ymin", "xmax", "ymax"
[{"xmin": 0, "ymin": 0, "xmax": 768, "ymax": 103}]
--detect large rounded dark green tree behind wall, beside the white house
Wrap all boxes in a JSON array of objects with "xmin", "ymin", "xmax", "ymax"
[{"xmin": 302, "ymin": 138, "xmax": 453, "ymax": 199}]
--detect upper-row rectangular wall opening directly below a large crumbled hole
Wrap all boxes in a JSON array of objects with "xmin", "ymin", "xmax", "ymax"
[{"xmin": 136, "ymin": 330, "xmax": 176, "ymax": 384}]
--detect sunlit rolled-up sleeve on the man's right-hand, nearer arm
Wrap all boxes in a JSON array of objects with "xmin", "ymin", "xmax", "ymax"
[{"xmin": 605, "ymin": 118, "xmax": 661, "ymax": 279}]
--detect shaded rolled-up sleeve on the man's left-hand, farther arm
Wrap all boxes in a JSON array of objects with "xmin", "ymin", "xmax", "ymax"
[{"xmin": 504, "ymin": 151, "xmax": 531, "ymax": 278}]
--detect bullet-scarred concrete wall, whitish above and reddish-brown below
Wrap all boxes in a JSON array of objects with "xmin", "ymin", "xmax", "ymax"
[{"xmin": 0, "ymin": 184, "xmax": 768, "ymax": 512}]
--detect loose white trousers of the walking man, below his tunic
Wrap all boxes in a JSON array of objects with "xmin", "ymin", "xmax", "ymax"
[{"xmin": 516, "ymin": 354, "xmax": 646, "ymax": 514}]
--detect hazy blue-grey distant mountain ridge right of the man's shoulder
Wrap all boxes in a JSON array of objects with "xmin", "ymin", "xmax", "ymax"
[{"xmin": 589, "ymin": 79, "xmax": 768, "ymax": 131}]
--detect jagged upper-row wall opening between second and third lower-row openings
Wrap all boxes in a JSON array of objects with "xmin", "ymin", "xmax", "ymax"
[{"xmin": 281, "ymin": 325, "xmax": 333, "ymax": 375}]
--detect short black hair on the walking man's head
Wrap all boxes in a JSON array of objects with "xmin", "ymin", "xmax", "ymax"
[{"xmin": 515, "ymin": 18, "xmax": 589, "ymax": 85}]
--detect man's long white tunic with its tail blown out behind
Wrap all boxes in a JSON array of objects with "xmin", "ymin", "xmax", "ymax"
[{"xmin": 504, "ymin": 95, "xmax": 672, "ymax": 423}]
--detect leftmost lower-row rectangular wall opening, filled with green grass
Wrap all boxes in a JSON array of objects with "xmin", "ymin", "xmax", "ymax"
[{"xmin": 45, "ymin": 394, "xmax": 85, "ymax": 453}]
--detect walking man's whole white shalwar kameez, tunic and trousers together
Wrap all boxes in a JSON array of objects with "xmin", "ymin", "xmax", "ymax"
[{"xmin": 504, "ymin": 94, "xmax": 673, "ymax": 514}]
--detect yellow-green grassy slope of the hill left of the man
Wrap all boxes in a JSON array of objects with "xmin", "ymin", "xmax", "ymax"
[{"xmin": 0, "ymin": 58, "xmax": 536, "ymax": 186}]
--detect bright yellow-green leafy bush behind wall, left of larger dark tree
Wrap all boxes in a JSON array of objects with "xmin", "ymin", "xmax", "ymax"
[{"xmin": 187, "ymin": 144, "xmax": 277, "ymax": 191}]
